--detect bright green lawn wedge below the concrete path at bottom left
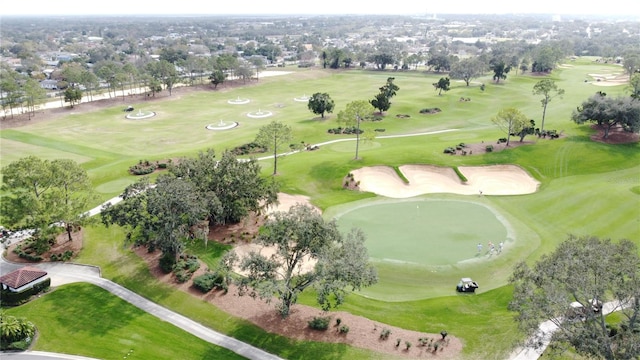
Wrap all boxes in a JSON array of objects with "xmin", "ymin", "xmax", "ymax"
[{"xmin": 7, "ymin": 284, "xmax": 244, "ymax": 359}]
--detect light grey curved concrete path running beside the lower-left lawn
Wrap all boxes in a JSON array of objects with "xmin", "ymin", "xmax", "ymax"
[{"xmin": 0, "ymin": 256, "xmax": 281, "ymax": 360}]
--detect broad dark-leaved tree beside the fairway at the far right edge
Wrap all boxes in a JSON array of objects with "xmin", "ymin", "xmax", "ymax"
[{"xmin": 571, "ymin": 92, "xmax": 640, "ymax": 139}]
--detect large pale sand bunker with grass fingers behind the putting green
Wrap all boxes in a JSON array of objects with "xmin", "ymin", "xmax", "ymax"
[{"xmin": 352, "ymin": 165, "xmax": 540, "ymax": 198}]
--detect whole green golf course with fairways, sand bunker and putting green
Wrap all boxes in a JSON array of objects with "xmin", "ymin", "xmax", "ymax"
[{"xmin": 0, "ymin": 57, "xmax": 640, "ymax": 359}]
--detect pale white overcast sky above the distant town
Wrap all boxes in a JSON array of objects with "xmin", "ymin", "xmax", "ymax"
[{"xmin": 0, "ymin": 0, "xmax": 640, "ymax": 18}]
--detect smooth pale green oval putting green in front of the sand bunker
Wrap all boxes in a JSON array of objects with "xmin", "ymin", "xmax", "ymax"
[{"xmin": 335, "ymin": 199, "xmax": 513, "ymax": 266}]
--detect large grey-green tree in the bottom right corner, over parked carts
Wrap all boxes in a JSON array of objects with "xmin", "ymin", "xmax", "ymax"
[{"xmin": 509, "ymin": 235, "xmax": 640, "ymax": 359}]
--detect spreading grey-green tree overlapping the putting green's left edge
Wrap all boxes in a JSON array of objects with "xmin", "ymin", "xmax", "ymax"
[{"xmin": 240, "ymin": 204, "xmax": 377, "ymax": 317}]
